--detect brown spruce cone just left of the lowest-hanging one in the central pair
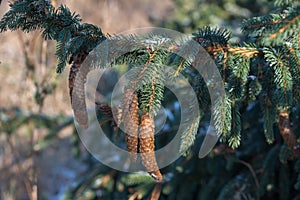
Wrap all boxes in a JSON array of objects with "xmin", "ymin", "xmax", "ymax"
[{"xmin": 122, "ymin": 88, "xmax": 139, "ymax": 162}]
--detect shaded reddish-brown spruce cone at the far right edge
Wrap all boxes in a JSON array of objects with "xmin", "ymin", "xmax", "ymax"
[{"xmin": 278, "ymin": 110, "xmax": 300, "ymax": 159}]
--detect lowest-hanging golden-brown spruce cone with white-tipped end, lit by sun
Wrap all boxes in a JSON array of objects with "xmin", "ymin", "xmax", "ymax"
[{"xmin": 139, "ymin": 112, "xmax": 163, "ymax": 180}]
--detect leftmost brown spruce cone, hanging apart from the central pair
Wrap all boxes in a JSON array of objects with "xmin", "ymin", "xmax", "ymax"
[{"xmin": 69, "ymin": 51, "xmax": 88, "ymax": 128}]
